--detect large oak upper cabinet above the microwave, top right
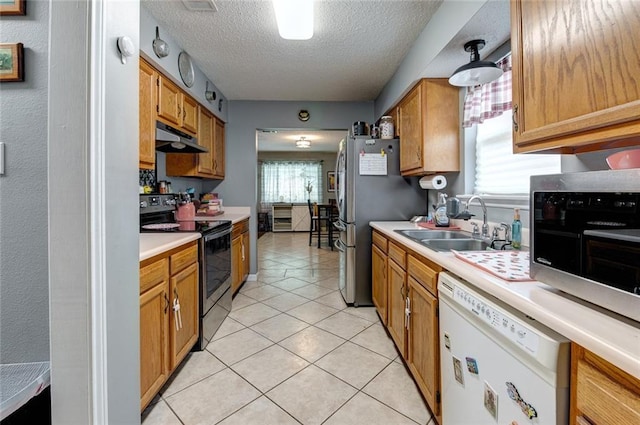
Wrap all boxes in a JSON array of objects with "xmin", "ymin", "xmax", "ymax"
[{"xmin": 511, "ymin": 0, "xmax": 640, "ymax": 153}]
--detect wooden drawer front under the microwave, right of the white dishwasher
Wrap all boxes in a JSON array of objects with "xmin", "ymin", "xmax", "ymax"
[{"xmin": 576, "ymin": 360, "xmax": 640, "ymax": 424}]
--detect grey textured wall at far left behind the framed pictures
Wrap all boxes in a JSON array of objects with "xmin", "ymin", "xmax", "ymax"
[{"xmin": 0, "ymin": 1, "xmax": 49, "ymax": 363}]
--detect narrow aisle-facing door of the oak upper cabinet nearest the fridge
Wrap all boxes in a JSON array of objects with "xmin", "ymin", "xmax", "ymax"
[{"xmin": 398, "ymin": 85, "xmax": 423, "ymax": 172}]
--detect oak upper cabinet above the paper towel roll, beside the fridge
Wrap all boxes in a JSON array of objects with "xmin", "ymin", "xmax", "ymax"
[{"xmin": 396, "ymin": 79, "xmax": 460, "ymax": 175}]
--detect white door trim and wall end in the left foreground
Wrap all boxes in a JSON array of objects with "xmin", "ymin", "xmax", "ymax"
[{"xmin": 48, "ymin": 0, "xmax": 140, "ymax": 425}]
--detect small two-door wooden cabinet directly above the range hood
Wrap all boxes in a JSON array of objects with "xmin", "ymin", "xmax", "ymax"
[{"xmin": 157, "ymin": 73, "xmax": 198, "ymax": 135}]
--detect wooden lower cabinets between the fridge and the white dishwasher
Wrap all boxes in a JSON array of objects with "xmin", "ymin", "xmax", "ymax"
[{"xmin": 371, "ymin": 231, "xmax": 442, "ymax": 422}]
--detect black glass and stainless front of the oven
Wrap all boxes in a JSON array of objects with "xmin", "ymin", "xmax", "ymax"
[{"xmin": 196, "ymin": 221, "xmax": 232, "ymax": 350}]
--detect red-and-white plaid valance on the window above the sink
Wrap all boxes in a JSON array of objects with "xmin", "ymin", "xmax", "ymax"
[{"xmin": 462, "ymin": 53, "xmax": 512, "ymax": 127}]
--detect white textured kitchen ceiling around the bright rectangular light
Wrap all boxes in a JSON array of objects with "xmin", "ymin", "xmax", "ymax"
[{"xmin": 142, "ymin": 0, "xmax": 441, "ymax": 101}]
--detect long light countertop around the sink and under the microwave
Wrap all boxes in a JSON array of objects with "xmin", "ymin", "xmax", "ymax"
[{"xmin": 369, "ymin": 221, "xmax": 640, "ymax": 379}]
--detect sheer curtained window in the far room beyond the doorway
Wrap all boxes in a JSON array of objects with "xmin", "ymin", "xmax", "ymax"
[{"xmin": 260, "ymin": 161, "xmax": 323, "ymax": 204}]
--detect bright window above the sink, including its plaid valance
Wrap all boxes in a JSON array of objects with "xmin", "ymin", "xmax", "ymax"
[{"xmin": 463, "ymin": 54, "xmax": 561, "ymax": 195}]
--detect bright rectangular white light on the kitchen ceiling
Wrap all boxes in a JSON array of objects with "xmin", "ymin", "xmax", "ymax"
[{"xmin": 273, "ymin": 0, "xmax": 313, "ymax": 40}]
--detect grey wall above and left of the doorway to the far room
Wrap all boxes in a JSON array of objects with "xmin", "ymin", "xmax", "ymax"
[{"xmin": 203, "ymin": 101, "xmax": 373, "ymax": 273}]
